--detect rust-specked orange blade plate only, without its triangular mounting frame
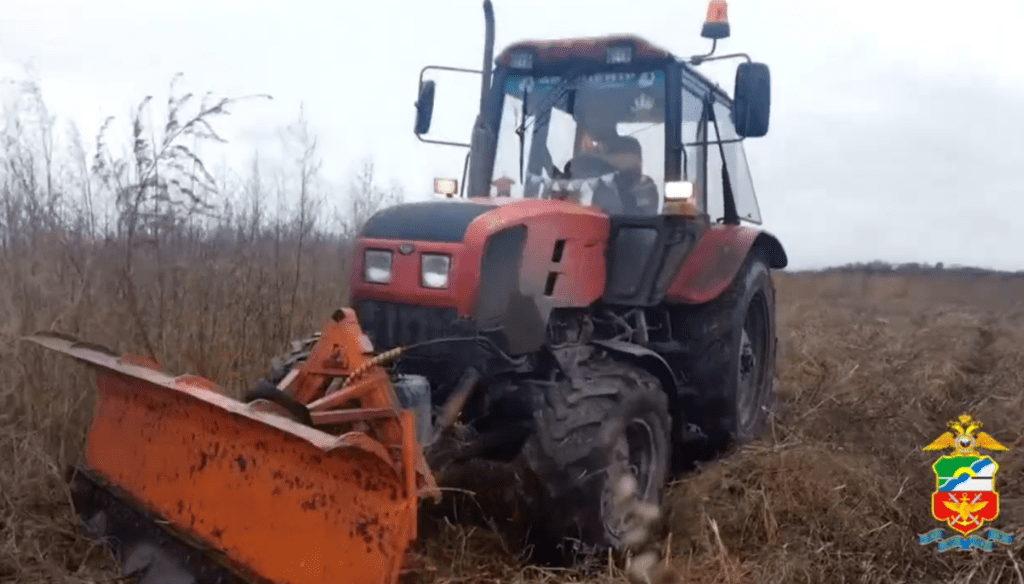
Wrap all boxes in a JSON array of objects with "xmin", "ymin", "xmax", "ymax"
[{"xmin": 27, "ymin": 335, "xmax": 419, "ymax": 584}]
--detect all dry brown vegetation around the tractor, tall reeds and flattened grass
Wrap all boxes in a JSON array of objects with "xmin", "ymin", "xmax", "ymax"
[{"xmin": 0, "ymin": 71, "xmax": 1024, "ymax": 584}]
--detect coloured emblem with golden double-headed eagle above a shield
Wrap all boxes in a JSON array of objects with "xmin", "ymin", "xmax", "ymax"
[{"xmin": 920, "ymin": 415, "xmax": 1013, "ymax": 551}]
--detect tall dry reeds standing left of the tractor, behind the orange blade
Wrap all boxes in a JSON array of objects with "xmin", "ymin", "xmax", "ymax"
[{"xmin": 0, "ymin": 71, "xmax": 401, "ymax": 582}]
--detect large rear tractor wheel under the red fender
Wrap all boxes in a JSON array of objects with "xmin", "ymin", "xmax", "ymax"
[{"xmin": 686, "ymin": 252, "xmax": 776, "ymax": 454}]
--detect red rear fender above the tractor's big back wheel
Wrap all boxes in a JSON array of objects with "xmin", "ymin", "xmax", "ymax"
[{"xmin": 666, "ymin": 225, "xmax": 788, "ymax": 304}]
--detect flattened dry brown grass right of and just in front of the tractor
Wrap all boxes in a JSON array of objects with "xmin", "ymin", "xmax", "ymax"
[{"xmin": 393, "ymin": 273, "xmax": 1024, "ymax": 584}]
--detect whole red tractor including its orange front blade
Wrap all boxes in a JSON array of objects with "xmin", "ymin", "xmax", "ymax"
[{"xmin": 28, "ymin": 0, "xmax": 786, "ymax": 584}]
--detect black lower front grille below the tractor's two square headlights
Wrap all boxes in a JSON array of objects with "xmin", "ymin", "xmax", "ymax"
[{"xmin": 353, "ymin": 300, "xmax": 458, "ymax": 351}]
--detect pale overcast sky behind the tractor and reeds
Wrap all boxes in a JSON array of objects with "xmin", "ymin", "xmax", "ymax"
[{"xmin": 0, "ymin": 0, "xmax": 1024, "ymax": 269}]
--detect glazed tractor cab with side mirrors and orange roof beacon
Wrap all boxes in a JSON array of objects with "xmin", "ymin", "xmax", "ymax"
[{"xmin": 416, "ymin": 0, "xmax": 770, "ymax": 229}]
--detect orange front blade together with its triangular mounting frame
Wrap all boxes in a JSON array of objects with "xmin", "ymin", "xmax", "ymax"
[{"xmin": 27, "ymin": 308, "xmax": 435, "ymax": 584}]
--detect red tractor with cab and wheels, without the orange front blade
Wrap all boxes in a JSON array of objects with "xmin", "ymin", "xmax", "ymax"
[{"xmin": 327, "ymin": 0, "xmax": 786, "ymax": 565}]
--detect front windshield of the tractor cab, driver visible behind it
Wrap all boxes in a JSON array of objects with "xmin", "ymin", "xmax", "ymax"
[{"xmin": 490, "ymin": 71, "xmax": 666, "ymax": 215}]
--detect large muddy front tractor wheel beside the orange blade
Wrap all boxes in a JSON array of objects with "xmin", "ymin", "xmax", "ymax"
[{"xmin": 521, "ymin": 356, "xmax": 672, "ymax": 564}]
